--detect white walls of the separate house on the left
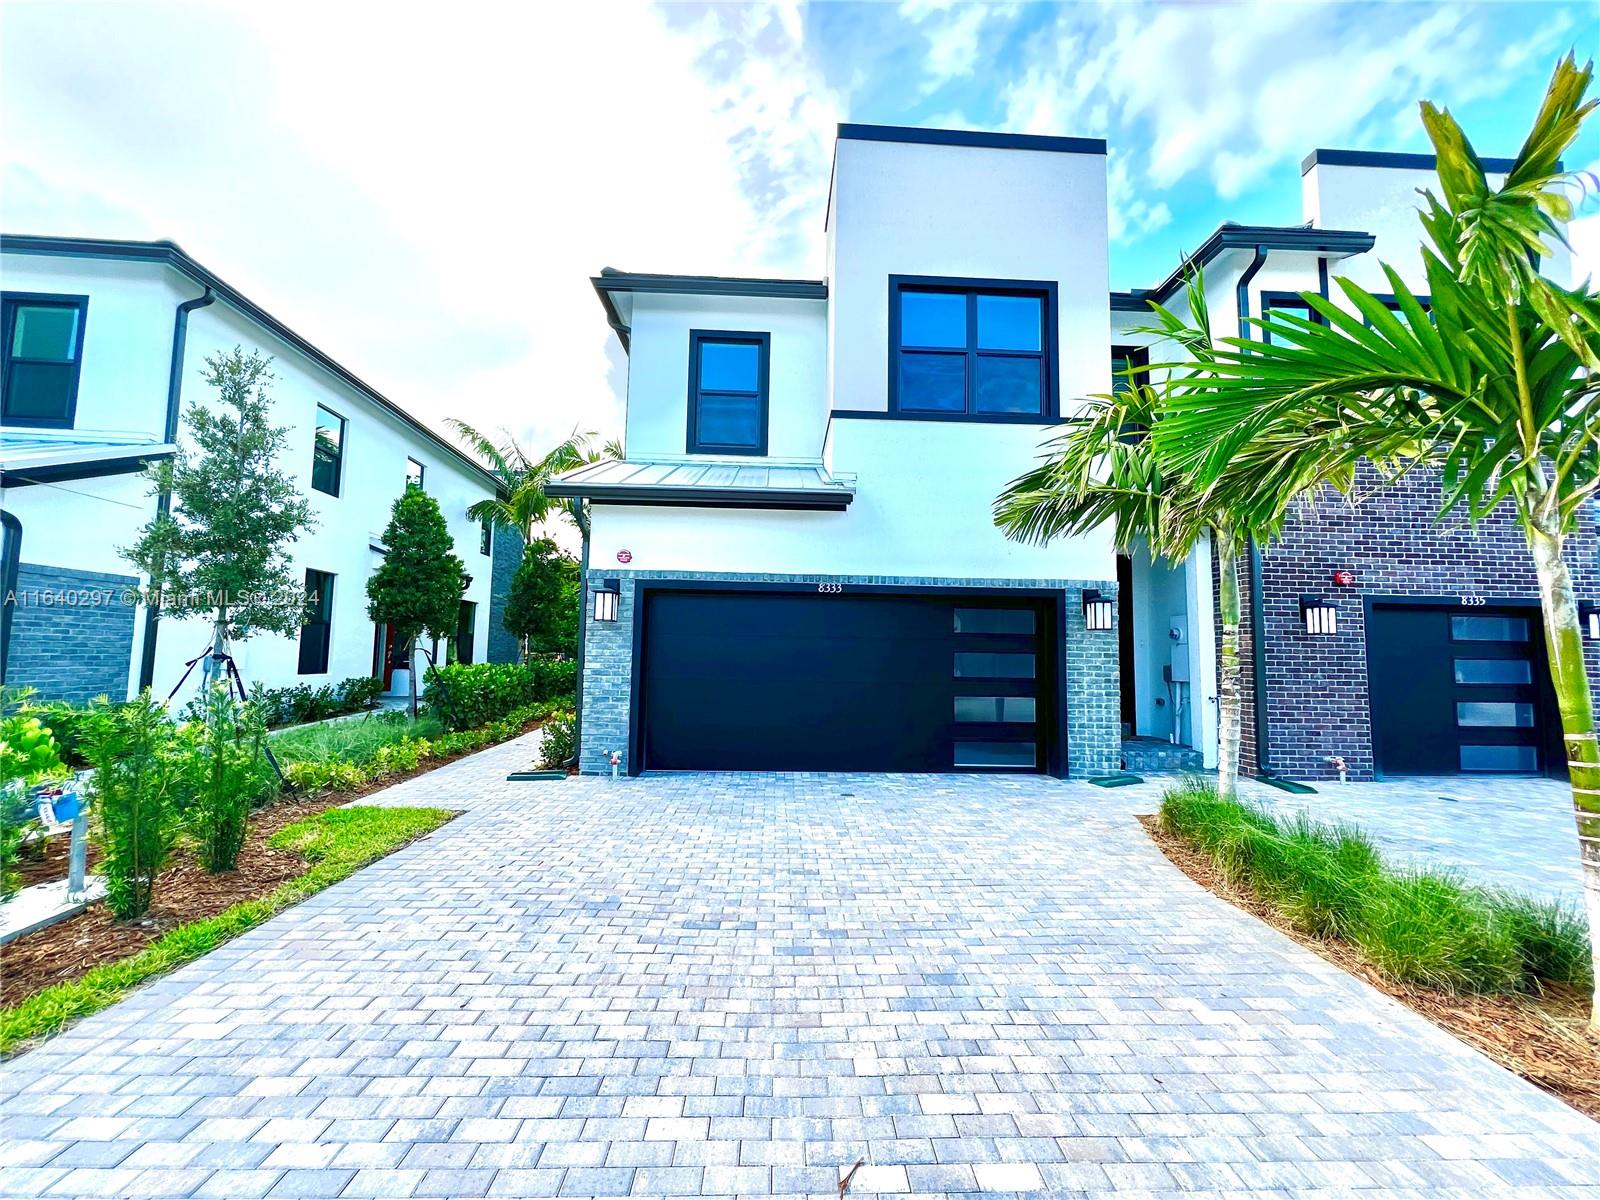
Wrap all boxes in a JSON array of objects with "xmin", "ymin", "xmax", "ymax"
[{"xmin": 0, "ymin": 254, "xmax": 491, "ymax": 696}]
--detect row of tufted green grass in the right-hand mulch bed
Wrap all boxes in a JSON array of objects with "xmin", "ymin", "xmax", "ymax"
[{"xmin": 1158, "ymin": 781, "xmax": 1594, "ymax": 994}]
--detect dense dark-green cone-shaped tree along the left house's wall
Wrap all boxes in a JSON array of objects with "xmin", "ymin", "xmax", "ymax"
[{"xmin": 366, "ymin": 488, "xmax": 467, "ymax": 717}]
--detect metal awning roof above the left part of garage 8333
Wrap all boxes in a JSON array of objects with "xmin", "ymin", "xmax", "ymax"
[{"xmin": 544, "ymin": 459, "xmax": 856, "ymax": 512}]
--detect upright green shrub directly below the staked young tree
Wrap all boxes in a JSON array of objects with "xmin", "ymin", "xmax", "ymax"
[{"xmin": 184, "ymin": 683, "xmax": 277, "ymax": 875}]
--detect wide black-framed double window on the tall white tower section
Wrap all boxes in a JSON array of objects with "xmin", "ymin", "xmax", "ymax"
[{"xmin": 890, "ymin": 275, "xmax": 1056, "ymax": 421}]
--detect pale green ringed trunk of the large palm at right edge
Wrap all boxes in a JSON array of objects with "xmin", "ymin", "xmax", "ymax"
[{"xmin": 1528, "ymin": 515, "xmax": 1600, "ymax": 1034}]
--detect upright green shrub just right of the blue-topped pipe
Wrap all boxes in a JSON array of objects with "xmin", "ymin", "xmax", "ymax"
[{"xmin": 83, "ymin": 691, "xmax": 184, "ymax": 918}]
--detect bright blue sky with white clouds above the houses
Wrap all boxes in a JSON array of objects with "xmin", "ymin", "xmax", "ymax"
[{"xmin": 0, "ymin": 0, "xmax": 1600, "ymax": 445}]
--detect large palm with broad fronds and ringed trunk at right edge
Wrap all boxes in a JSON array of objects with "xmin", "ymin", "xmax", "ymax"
[{"xmin": 1154, "ymin": 54, "xmax": 1600, "ymax": 1032}]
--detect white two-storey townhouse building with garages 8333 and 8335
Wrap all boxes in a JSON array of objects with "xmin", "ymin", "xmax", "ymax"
[{"xmin": 549, "ymin": 125, "xmax": 1600, "ymax": 790}]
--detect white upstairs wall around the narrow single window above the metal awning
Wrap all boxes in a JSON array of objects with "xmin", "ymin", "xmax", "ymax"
[{"xmin": 624, "ymin": 293, "xmax": 827, "ymax": 462}]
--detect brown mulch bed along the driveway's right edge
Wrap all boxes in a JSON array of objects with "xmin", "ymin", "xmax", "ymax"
[{"xmin": 1139, "ymin": 816, "xmax": 1600, "ymax": 1118}]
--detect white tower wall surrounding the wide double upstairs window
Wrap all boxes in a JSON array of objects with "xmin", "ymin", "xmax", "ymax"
[{"xmin": 829, "ymin": 139, "xmax": 1110, "ymax": 412}]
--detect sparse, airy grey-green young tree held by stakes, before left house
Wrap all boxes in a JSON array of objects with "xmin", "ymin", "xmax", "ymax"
[{"xmin": 123, "ymin": 347, "xmax": 312, "ymax": 682}]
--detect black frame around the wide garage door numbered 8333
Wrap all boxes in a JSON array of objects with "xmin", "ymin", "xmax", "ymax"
[{"xmin": 627, "ymin": 578, "xmax": 1069, "ymax": 779}]
